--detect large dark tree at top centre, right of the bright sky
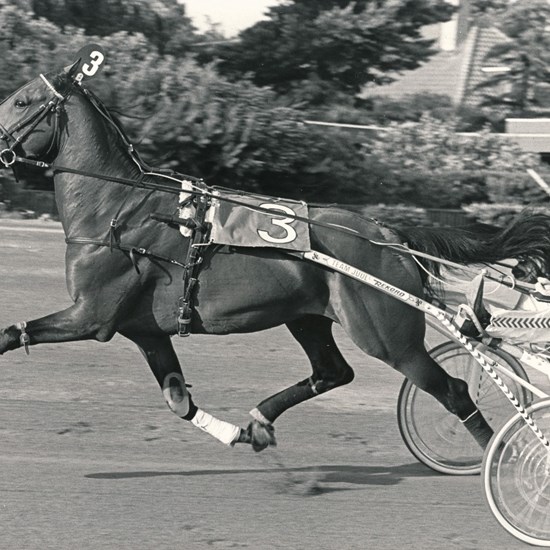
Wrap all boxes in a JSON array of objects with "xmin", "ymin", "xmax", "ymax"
[{"xmin": 209, "ymin": 0, "xmax": 455, "ymax": 103}]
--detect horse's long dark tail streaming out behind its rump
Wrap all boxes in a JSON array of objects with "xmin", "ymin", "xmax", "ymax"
[{"xmin": 398, "ymin": 210, "xmax": 550, "ymax": 275}]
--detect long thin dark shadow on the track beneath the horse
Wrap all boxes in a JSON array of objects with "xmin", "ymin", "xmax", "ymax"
[{"xmin": 85, "ymin": 463, "xmax": 441, "ymax": 493}]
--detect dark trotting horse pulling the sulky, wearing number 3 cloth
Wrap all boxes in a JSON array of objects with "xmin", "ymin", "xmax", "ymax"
[{"xmin": 0, "ymin": 61, "xmax": 550, "ymax": 450}]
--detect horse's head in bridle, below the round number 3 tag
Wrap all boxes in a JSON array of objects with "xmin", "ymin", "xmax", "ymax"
[{"xmin": 0, "ymin": 69, "xmax": 78, "ymax": 166}]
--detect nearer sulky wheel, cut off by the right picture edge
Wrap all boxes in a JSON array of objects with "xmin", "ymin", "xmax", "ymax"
[{"xmin": 482, "ymin": 399, "xmax": 550, "ymax": 547}]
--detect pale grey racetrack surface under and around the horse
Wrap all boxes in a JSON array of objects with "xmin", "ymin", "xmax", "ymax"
[{"xmin": 0, "ymin": 220, "xmax": 548, "ymax": 550}]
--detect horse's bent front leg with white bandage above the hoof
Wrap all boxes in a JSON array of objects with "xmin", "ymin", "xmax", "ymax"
[{"xmin": 123, "ymin": 333, "xmax": 250, "ymax": 447}]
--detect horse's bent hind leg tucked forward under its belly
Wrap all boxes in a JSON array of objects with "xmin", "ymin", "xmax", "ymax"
[{"xmin": 249, "ymin": 315, "xmax": 354, "ymax": 451}]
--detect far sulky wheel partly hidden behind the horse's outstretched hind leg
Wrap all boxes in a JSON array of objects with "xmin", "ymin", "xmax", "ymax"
[{"xmin": 397, "ymin": 342, "xmax": 531, "ymax": 475}]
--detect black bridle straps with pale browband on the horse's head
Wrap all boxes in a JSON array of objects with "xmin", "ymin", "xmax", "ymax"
[{"xmin": 0, "ymin": 74, "xmax": 70, "ymax": 167}]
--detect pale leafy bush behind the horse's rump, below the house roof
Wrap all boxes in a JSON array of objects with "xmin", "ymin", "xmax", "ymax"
[{"xmin": 365, "ymin": 115, "xmax": 540, "ymax": 208}]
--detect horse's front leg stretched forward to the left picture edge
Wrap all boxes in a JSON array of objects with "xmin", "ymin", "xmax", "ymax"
[{"xmin": 0, "ymin": 302, "xmax": 115, "ymax": 355}]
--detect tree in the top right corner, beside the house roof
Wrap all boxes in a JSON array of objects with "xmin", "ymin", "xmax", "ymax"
[{"xmin": 480, "ymin": 0, "xmax": 550, "ymax": 116}]
